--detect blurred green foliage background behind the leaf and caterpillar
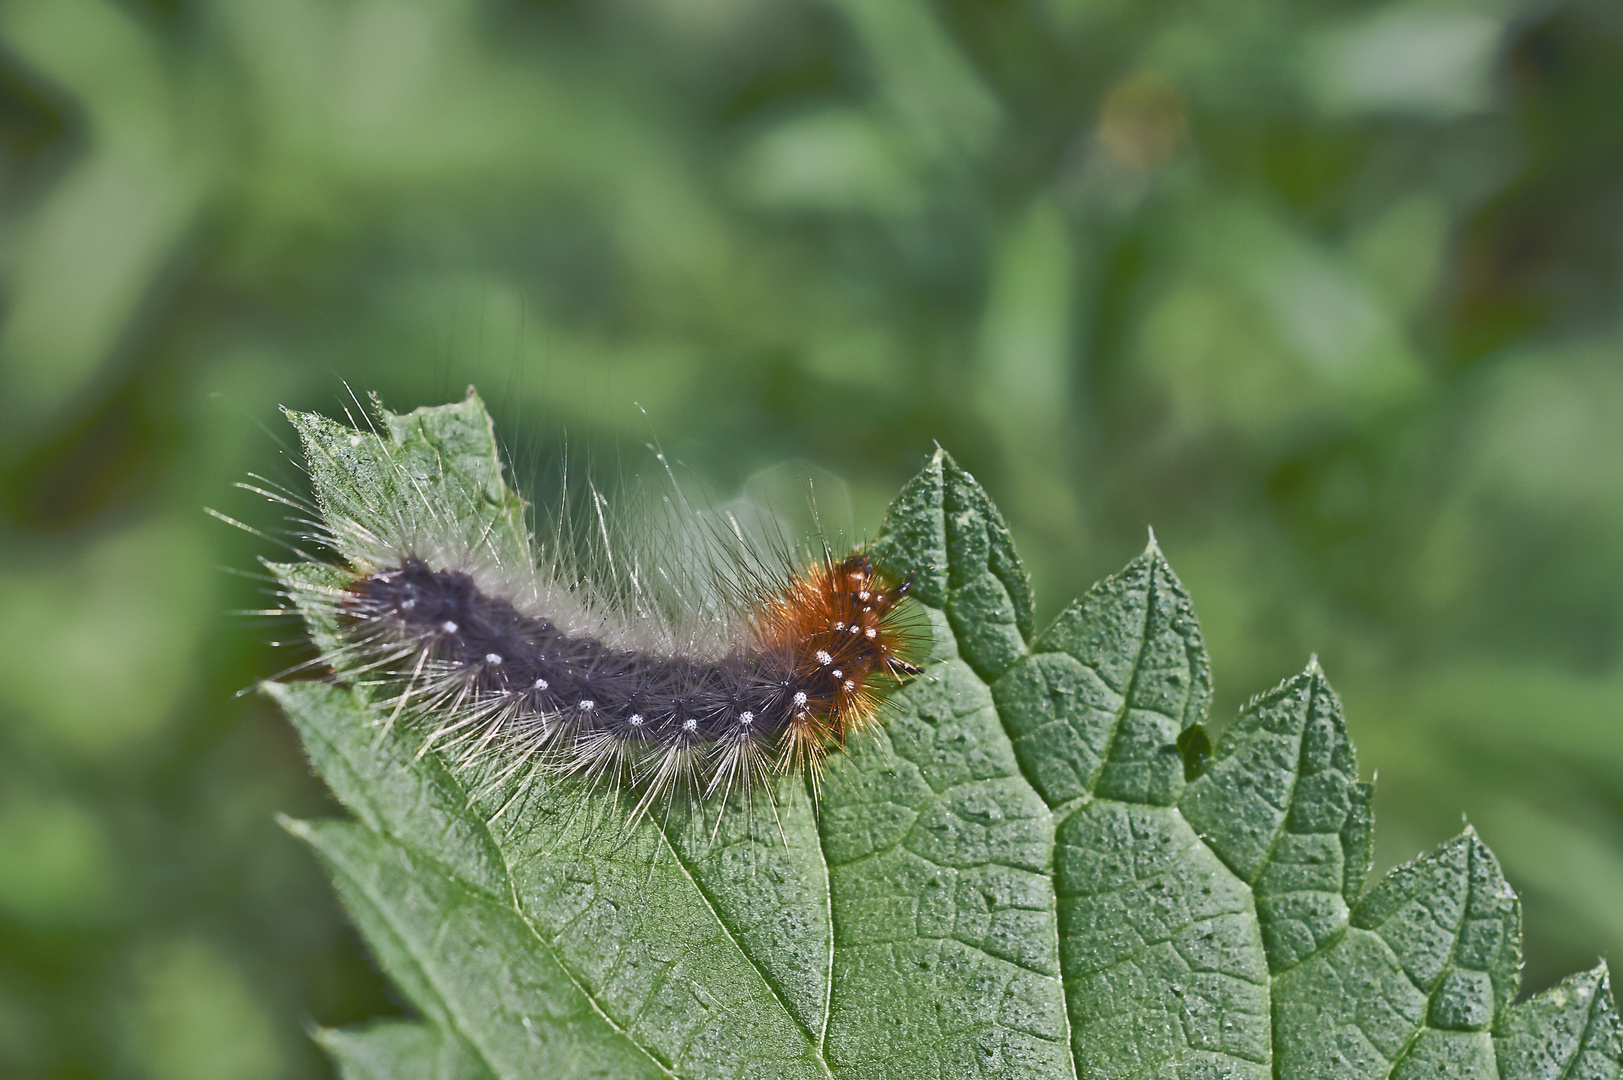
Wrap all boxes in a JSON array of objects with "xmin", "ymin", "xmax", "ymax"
[{"xmin": 0, "ymin": 0, "xmax": 1623, "ymax": 1080}]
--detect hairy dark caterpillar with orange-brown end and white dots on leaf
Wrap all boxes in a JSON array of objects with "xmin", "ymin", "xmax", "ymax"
[{"xmin": 248, "ymin": 391, "xmax": 920, "ymax": 822}]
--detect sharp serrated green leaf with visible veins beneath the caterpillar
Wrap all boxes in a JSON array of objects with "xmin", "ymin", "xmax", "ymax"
[{"xmin": 266, "ymin": 396, "xmax": 1623, "ymax": 1080}]
